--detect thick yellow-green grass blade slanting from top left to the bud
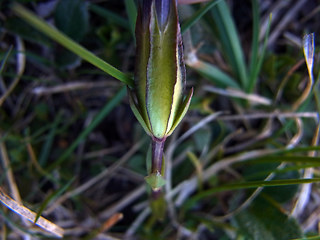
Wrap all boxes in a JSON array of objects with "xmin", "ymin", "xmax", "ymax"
[{"xmin": 12, "ymin": 3, "xmax": 133, "ymax": 86}]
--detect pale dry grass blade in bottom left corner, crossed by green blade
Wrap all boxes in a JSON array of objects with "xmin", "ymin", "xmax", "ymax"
[{"xmin": 0, "ymin": 188, "xmax": 63, "ymax": 238}]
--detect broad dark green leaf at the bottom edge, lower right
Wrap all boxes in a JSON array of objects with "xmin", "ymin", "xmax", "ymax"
[{"xmin": 234, "ymin": 197, "xmax": 302, "ymax": 240}]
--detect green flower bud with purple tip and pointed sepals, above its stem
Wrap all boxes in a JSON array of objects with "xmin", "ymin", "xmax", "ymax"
[{"xmin": 129, "ymin": 0, "xmax": 193, "ymax": 139}]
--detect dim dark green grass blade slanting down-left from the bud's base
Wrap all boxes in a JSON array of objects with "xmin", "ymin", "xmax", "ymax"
[{"xmin": 48, "ymin": 87, "xmax": 126, "ymax": 172}]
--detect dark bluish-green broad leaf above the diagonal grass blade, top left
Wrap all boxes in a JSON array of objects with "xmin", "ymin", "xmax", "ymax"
[{"xmin": 54, "ymin": 0, "xmax": 89, "ymax": 42}]
